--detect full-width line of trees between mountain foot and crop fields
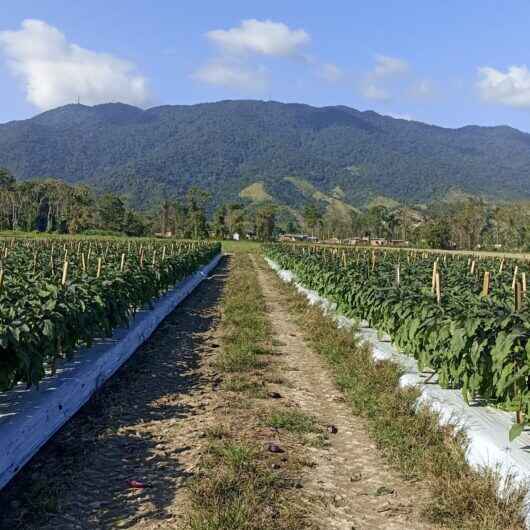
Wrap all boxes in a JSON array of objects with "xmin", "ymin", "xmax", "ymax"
[{"xmin": 0, "ymin": 168, "xmax": 530, "ymax": 251}]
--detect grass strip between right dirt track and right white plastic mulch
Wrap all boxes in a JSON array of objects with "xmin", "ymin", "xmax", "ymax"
[{"xmin": 275, "ymin": 260, "xmax": 526, "ymax": 530}]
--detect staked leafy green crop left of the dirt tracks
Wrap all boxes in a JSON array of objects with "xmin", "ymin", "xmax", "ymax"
[{"xmin": 0, "ymin": 239, "xmax": 220, "ymax": 391}]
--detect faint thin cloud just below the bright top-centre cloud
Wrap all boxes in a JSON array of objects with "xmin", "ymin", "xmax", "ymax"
[{"xmin": 192, "ymin": 60, "xmax": 267, "ymax": 92}]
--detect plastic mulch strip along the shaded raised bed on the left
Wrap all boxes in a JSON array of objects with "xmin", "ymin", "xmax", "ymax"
[{"xmin": 0, "ymin": 254, "xmax": 221, "ymax": 488}]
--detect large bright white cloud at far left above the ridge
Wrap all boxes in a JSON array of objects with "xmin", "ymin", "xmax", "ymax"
[{"xmin": 0, "ymin": 19, "xmax": 150, "ymax": 110}]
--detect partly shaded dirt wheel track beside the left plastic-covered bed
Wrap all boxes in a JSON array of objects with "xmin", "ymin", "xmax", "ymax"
[{"xmin": 0, "ymin": 260, "xmax": 228, "ymax": 530}]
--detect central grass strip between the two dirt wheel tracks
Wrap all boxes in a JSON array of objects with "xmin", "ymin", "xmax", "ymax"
[{"xmin": 188, "ymin": 252, "xmax": 312, "ymax": 530}]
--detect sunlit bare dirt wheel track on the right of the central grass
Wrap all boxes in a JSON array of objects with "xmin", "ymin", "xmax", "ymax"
[{"xmin": 254, "ymin": 254, "xmax": 433, "ymax": 530}]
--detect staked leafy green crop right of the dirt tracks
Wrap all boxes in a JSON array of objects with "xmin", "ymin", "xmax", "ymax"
[{"xmin": 265, "ymin": 244, "xmax": 530, "ymax": 436}]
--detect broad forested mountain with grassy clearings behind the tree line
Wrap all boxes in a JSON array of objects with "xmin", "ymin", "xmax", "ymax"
[{"xmin": 0, "ymin": 101, "xmax": 530, "ymax": 211}]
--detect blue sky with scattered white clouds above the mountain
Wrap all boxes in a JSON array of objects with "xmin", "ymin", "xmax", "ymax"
[{"xmin": 0, "ymin": 0, "xmax": 530, "ymax": 132}]
